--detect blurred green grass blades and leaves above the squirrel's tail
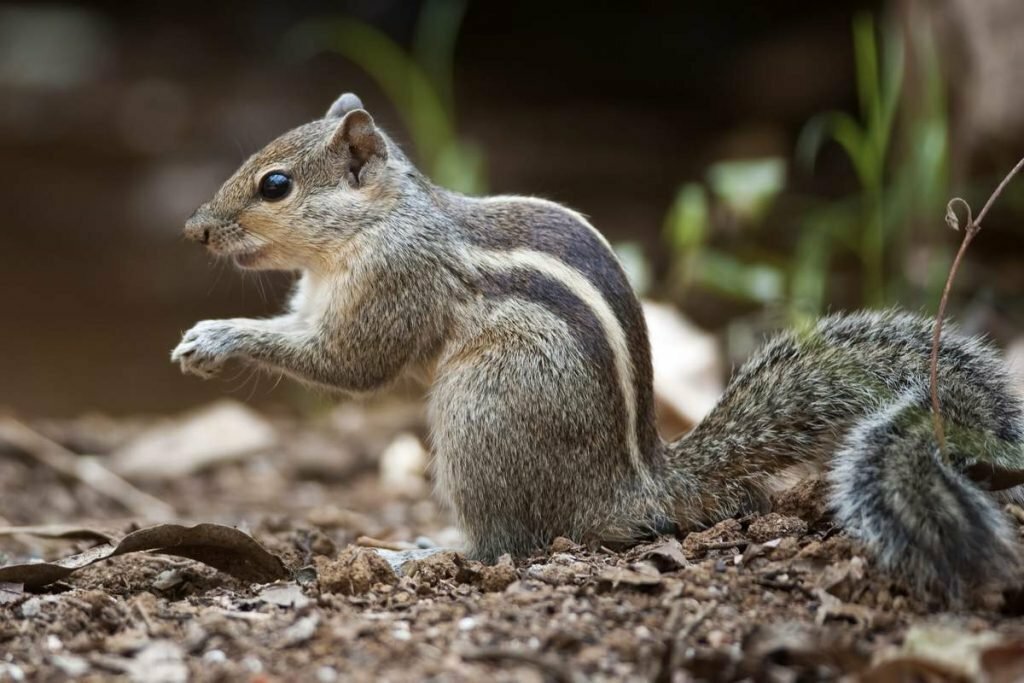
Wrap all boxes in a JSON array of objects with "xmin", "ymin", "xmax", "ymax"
[{"xmin": 666, "ymin": 10, "xmax": 950, "ymax": 323}]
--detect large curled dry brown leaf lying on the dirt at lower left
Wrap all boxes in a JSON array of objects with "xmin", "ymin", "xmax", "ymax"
[{"xmin": 0, "ymin": 524, "xmax": 289, "ymax": 589}]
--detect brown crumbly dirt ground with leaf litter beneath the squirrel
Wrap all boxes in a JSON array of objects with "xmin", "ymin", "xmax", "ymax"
[{"xmin": 0, "ymin": 405, "xmax": 1024, "ymax": 682}]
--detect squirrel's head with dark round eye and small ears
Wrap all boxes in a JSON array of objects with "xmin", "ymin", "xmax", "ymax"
[{"xmin": 184, "ymin": 92, "xmax": 411, "ymax": 270}]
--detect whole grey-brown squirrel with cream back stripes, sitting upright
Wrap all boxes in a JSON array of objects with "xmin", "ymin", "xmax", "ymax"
[{"xmin": 171, "ymin": 93, "xmax": 1024, "ymax": 597}]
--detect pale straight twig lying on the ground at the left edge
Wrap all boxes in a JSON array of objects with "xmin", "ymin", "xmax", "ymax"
[{"xmin": 0, "ymin": 417, "xmax": 175, "ymax": 520}]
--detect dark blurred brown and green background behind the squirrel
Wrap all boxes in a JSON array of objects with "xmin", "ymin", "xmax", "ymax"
[{"xmin": 0, "ymin": 0, "xmax": 1024, "ymax": 417}]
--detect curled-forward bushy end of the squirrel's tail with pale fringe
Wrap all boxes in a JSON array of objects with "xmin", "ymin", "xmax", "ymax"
[{"xmin": 829, "ymin": 388, "xmax": 1022, "ymax": 601}]
